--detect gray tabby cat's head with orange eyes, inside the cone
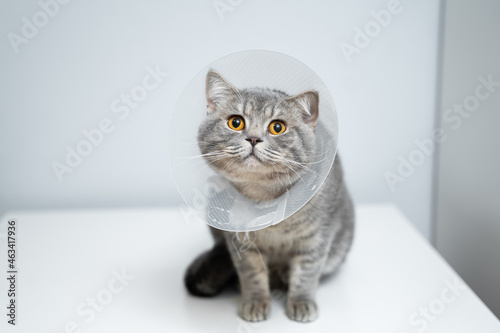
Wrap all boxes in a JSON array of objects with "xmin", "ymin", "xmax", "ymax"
[{"xmin": 198, "ymin": 71, "xmax": 319, "ymax": 200}]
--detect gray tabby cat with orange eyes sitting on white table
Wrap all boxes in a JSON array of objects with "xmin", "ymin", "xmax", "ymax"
[{"xmin": 185, "ymin": 71, "xmax": 354, "ymax": 322}]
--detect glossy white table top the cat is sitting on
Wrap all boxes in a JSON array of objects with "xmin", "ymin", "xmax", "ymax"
[{"xmin": 0, "ymin": 205, "xmax": 500, "ymax": 333}]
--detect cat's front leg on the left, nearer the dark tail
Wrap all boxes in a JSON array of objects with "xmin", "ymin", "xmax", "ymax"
[{"xmin": 228, "ymin": 233, "xmax": 271, "ymax": 321}]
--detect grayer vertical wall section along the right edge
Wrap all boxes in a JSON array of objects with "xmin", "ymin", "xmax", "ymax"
[{"xmin": 436, "ymin": 0, "xmax": 500, "ymax": 317}]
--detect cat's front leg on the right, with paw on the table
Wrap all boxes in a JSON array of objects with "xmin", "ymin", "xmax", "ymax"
[{"xmin": 286, "ymin": 253, "xmax": 326, "ymax": 322}]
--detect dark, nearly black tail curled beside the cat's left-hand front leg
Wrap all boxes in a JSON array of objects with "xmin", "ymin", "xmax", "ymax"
[{"xmin": 184, "ymin": 241, "xmax": 237, "ymax": 297}]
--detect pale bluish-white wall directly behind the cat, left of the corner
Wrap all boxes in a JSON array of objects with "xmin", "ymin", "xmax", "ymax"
[{"xmin": 0, "ymin": 0, "xmax": 439, "ymax": 236}]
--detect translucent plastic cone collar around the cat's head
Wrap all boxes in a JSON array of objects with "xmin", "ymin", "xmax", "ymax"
[{"xmin": 168, "ymin": 51, "xmax": 338, "ymax": 232}]
